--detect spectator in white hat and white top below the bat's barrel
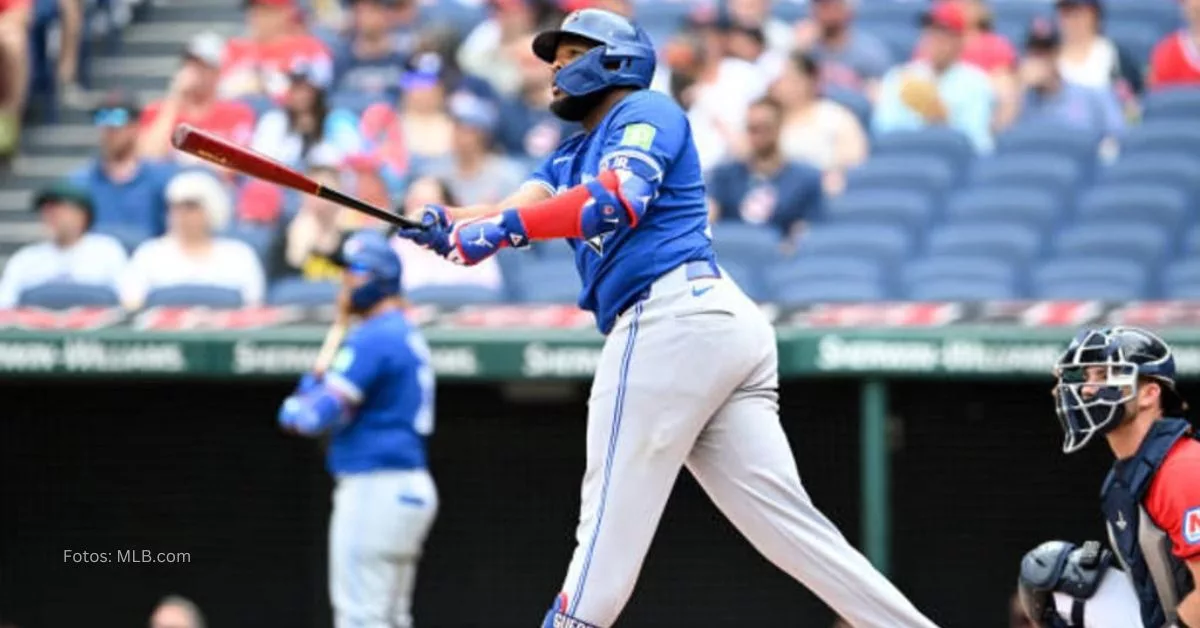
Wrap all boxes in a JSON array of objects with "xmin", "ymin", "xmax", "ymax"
[{"xmin": 119, "ymin": 171, "xmax": 265, "ymax": 310}]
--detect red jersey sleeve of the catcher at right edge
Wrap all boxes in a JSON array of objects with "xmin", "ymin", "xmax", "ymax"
[{"xmin": 1142, "ymin": 438, "xmax": 1200, "ymax": 561}]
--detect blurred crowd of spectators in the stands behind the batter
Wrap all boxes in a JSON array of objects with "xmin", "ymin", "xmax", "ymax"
[{"xmin": 0, "ymin": 0, "xmax": 1200, "ymax": 309}]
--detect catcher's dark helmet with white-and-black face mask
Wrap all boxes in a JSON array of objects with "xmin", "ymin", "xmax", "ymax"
[{"xmin": 1055, "ymin": 327, "xmax": 1187, "ymax": 454}]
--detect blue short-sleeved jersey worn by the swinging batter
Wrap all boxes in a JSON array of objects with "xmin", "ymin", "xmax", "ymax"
[{"xmin": 533, "ymin": 90, "xmax": 714, "ymax": 334}]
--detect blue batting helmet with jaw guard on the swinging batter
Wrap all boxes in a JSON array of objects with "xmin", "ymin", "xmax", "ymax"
[{"xmin": 533, "ymin": 8, "xmax": 655, "ymax": 96}]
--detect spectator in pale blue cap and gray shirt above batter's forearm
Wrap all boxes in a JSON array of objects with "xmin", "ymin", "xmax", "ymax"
[{"xmin": 426, "ymin": 90, "xmax": 524, "ymax": 205}]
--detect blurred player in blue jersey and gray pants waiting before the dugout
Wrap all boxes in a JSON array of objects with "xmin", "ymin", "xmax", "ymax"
[{"xmin": 278, "ymin": 231, "xmax": 438, "ymax": 628}]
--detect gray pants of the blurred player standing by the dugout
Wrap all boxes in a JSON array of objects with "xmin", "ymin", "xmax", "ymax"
[{"xmin": 329, "ymin": 469, "xmax": 438, "ymax": 628}]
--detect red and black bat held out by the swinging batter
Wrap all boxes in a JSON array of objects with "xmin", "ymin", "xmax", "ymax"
[{"xmin": 172, "ymin": 124, "xmax": 422, "ymax": 232}]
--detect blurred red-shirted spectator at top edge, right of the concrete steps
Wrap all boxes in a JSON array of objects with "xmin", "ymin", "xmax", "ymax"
[{"xmin": 220, "ymin": 0, "xmax": 332, "ymax": 98}]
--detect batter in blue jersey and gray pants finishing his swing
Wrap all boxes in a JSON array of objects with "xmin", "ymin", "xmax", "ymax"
[{"xmin": 401, "ymin": 10, "xmax": 934, "ymax": 628}]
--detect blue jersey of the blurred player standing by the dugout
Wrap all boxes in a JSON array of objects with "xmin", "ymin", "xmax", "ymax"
[{"xmin": 325, "ymin": 311, "xmax": 433, "ymax": 476}]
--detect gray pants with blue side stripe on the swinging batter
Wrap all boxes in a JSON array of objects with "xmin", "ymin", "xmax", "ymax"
[{"xmin": 552, "ymin": 264, "xmax": 934, "ymax": 628}]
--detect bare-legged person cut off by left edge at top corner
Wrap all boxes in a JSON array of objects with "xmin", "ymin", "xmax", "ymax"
[{"xmin": 0, "ymin": 0, "xmax": 34, "ymax": 161}]
